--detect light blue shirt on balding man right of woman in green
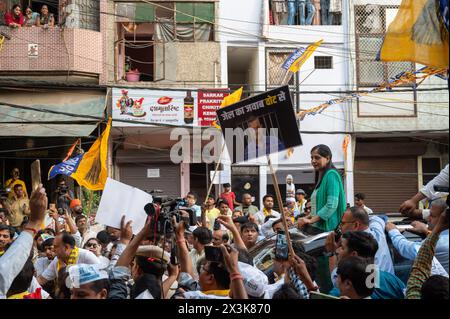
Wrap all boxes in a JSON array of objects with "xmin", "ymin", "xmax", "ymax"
[{"xmin": 366, "ymin": 216, "xmax": 395, "ymax": 274}]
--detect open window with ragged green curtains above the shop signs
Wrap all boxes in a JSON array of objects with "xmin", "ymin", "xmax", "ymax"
[{"xmin": 115, "ymin": 2, "xmax": 215, "ymax": 82}]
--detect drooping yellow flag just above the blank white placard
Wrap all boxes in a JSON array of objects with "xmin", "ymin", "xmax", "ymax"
[{"xmin": 70, "ymin": 118, "xmax": 112, "ymax": 190}]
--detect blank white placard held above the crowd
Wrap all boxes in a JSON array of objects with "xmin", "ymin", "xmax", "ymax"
[{"xmin": 95, "ymin": 178, "xmax": 153, "ymax": 234}]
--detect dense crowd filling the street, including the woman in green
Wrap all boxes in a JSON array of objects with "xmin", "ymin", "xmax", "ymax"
[{"xmin": 0, "ymin": 145, "xmax": 449, "ymax": 299}]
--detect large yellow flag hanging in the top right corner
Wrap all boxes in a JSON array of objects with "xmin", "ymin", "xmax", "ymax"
[{"xmin": 379, "ymin": 0, "xmax": 449, "ymax": 68}]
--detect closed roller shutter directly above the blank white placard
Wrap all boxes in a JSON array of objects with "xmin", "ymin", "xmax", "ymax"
[{"xmin": 120, "ymin": 163, "xmax": 181, "ymax": 198}]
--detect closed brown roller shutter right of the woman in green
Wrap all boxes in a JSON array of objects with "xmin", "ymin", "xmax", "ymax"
[{"xmin": 354, "ymin": 157, "xmax": 418, "ymax": 213}]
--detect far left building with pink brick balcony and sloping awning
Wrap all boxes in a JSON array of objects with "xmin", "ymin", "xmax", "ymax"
[{"xmin": 0, "ymin": 0, "xmax": 107, "ymax": 195}]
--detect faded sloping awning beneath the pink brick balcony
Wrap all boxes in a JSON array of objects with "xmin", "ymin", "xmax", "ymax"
[{"xmin": 0, "ymin": 91, "xmax": 106, "ymax": 137}]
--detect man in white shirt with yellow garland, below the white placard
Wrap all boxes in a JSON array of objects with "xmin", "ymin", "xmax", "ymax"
[{"xmin": 38, "ymin": 233, "xmax": 100, "ymax": 286}]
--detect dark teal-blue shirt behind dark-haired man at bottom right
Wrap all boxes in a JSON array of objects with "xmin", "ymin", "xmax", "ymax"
[{"xmin": 329, "ymin": 271, "xmax": 406, "ymax": 299}]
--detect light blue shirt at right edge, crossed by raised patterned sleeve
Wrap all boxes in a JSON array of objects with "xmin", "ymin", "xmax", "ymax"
[{"xmin": 389, "ymin": 229, "xmax": 449, "ymax": 275}]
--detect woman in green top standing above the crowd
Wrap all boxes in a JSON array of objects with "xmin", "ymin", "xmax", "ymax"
[{"xmin": 298, "ymin": 144, "xmax": 347, "ymax": 231}]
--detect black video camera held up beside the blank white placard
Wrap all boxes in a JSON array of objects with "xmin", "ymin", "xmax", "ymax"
[{"xmin": 144, "ymin": 196, "xmax": 197, "ymax": 235}]
